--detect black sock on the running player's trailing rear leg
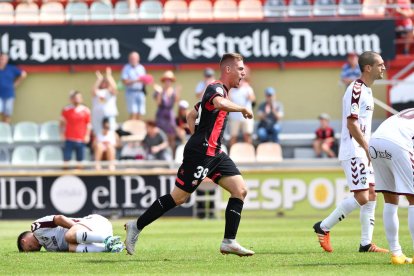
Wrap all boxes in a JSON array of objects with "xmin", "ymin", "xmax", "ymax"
[{"xmin": 137, "ymin": 194, "xmax": 176, "ymax": 230}]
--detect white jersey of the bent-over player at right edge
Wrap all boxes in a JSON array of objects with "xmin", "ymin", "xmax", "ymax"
[{"xmin": 372, "ymin": 108, "xmax": 414, "ymax": 151}]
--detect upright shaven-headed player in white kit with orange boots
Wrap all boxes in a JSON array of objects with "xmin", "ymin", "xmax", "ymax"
[{"xmin": 313, "ymin": 51, "xmax": 388, "ymax": 252}]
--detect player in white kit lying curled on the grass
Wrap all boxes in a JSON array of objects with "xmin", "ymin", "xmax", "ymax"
[{"xmin": 17, "ymin": 215, "xmax": 124, "ymax": 253}]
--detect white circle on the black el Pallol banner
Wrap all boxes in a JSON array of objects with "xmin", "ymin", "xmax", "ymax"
[{"xmin": 50, "ymin": 175, "xmax": 88, "ymax": 214}]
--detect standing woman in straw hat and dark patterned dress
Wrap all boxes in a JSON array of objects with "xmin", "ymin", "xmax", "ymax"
[{"xmin": 154, "ymin": 71, "xmax": 180, "ymax": 153}]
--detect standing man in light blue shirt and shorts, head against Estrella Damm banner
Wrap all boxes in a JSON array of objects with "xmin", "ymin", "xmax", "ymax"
[{"xmin": 121, "ymin": 52, "xmax": 146, "ymax": 120}]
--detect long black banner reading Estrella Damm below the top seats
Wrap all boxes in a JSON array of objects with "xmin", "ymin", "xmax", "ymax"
[{"xmin": 0, "ymin": 20, "xmax": 395, "ymax": 65}]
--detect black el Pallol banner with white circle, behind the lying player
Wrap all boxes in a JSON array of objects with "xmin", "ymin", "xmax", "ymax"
[{"xmin": 0, "ymin": 175, "xmax": 193, "ymax": 219}]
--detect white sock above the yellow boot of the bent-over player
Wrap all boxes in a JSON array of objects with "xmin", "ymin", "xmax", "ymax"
[{"xmin": 382, "ymin": 203, "xmax": 402, "ymax": 256}]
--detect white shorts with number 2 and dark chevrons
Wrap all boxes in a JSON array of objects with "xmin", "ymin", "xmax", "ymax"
[{"xmin": 341, "ymin": 157, "xmax": 375, "ymax": 191}]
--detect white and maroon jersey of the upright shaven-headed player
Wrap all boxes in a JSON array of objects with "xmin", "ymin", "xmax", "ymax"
[{"xmin": 338, "ymin": 79, "xmax": 374, "ymax": 160}]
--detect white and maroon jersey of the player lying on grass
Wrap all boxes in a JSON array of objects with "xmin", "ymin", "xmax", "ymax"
[{"xmin": 32, "ymin": 215, "xmax": 79, "ymax": 251}]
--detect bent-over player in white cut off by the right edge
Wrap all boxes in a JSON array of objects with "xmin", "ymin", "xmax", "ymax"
[{"xmin": 369, "ymin": 108, "xmax": 414, "ymax": 264}]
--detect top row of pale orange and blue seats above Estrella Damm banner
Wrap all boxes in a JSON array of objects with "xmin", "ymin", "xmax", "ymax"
[{"xmin": 0, "ymin": 0, "xmax": 392, "ymax": 24}]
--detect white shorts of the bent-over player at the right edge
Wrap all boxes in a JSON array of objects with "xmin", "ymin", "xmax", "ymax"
[{"xmin": 369, "ymin": 139, "xmax": 414, "ymax": 195}]
